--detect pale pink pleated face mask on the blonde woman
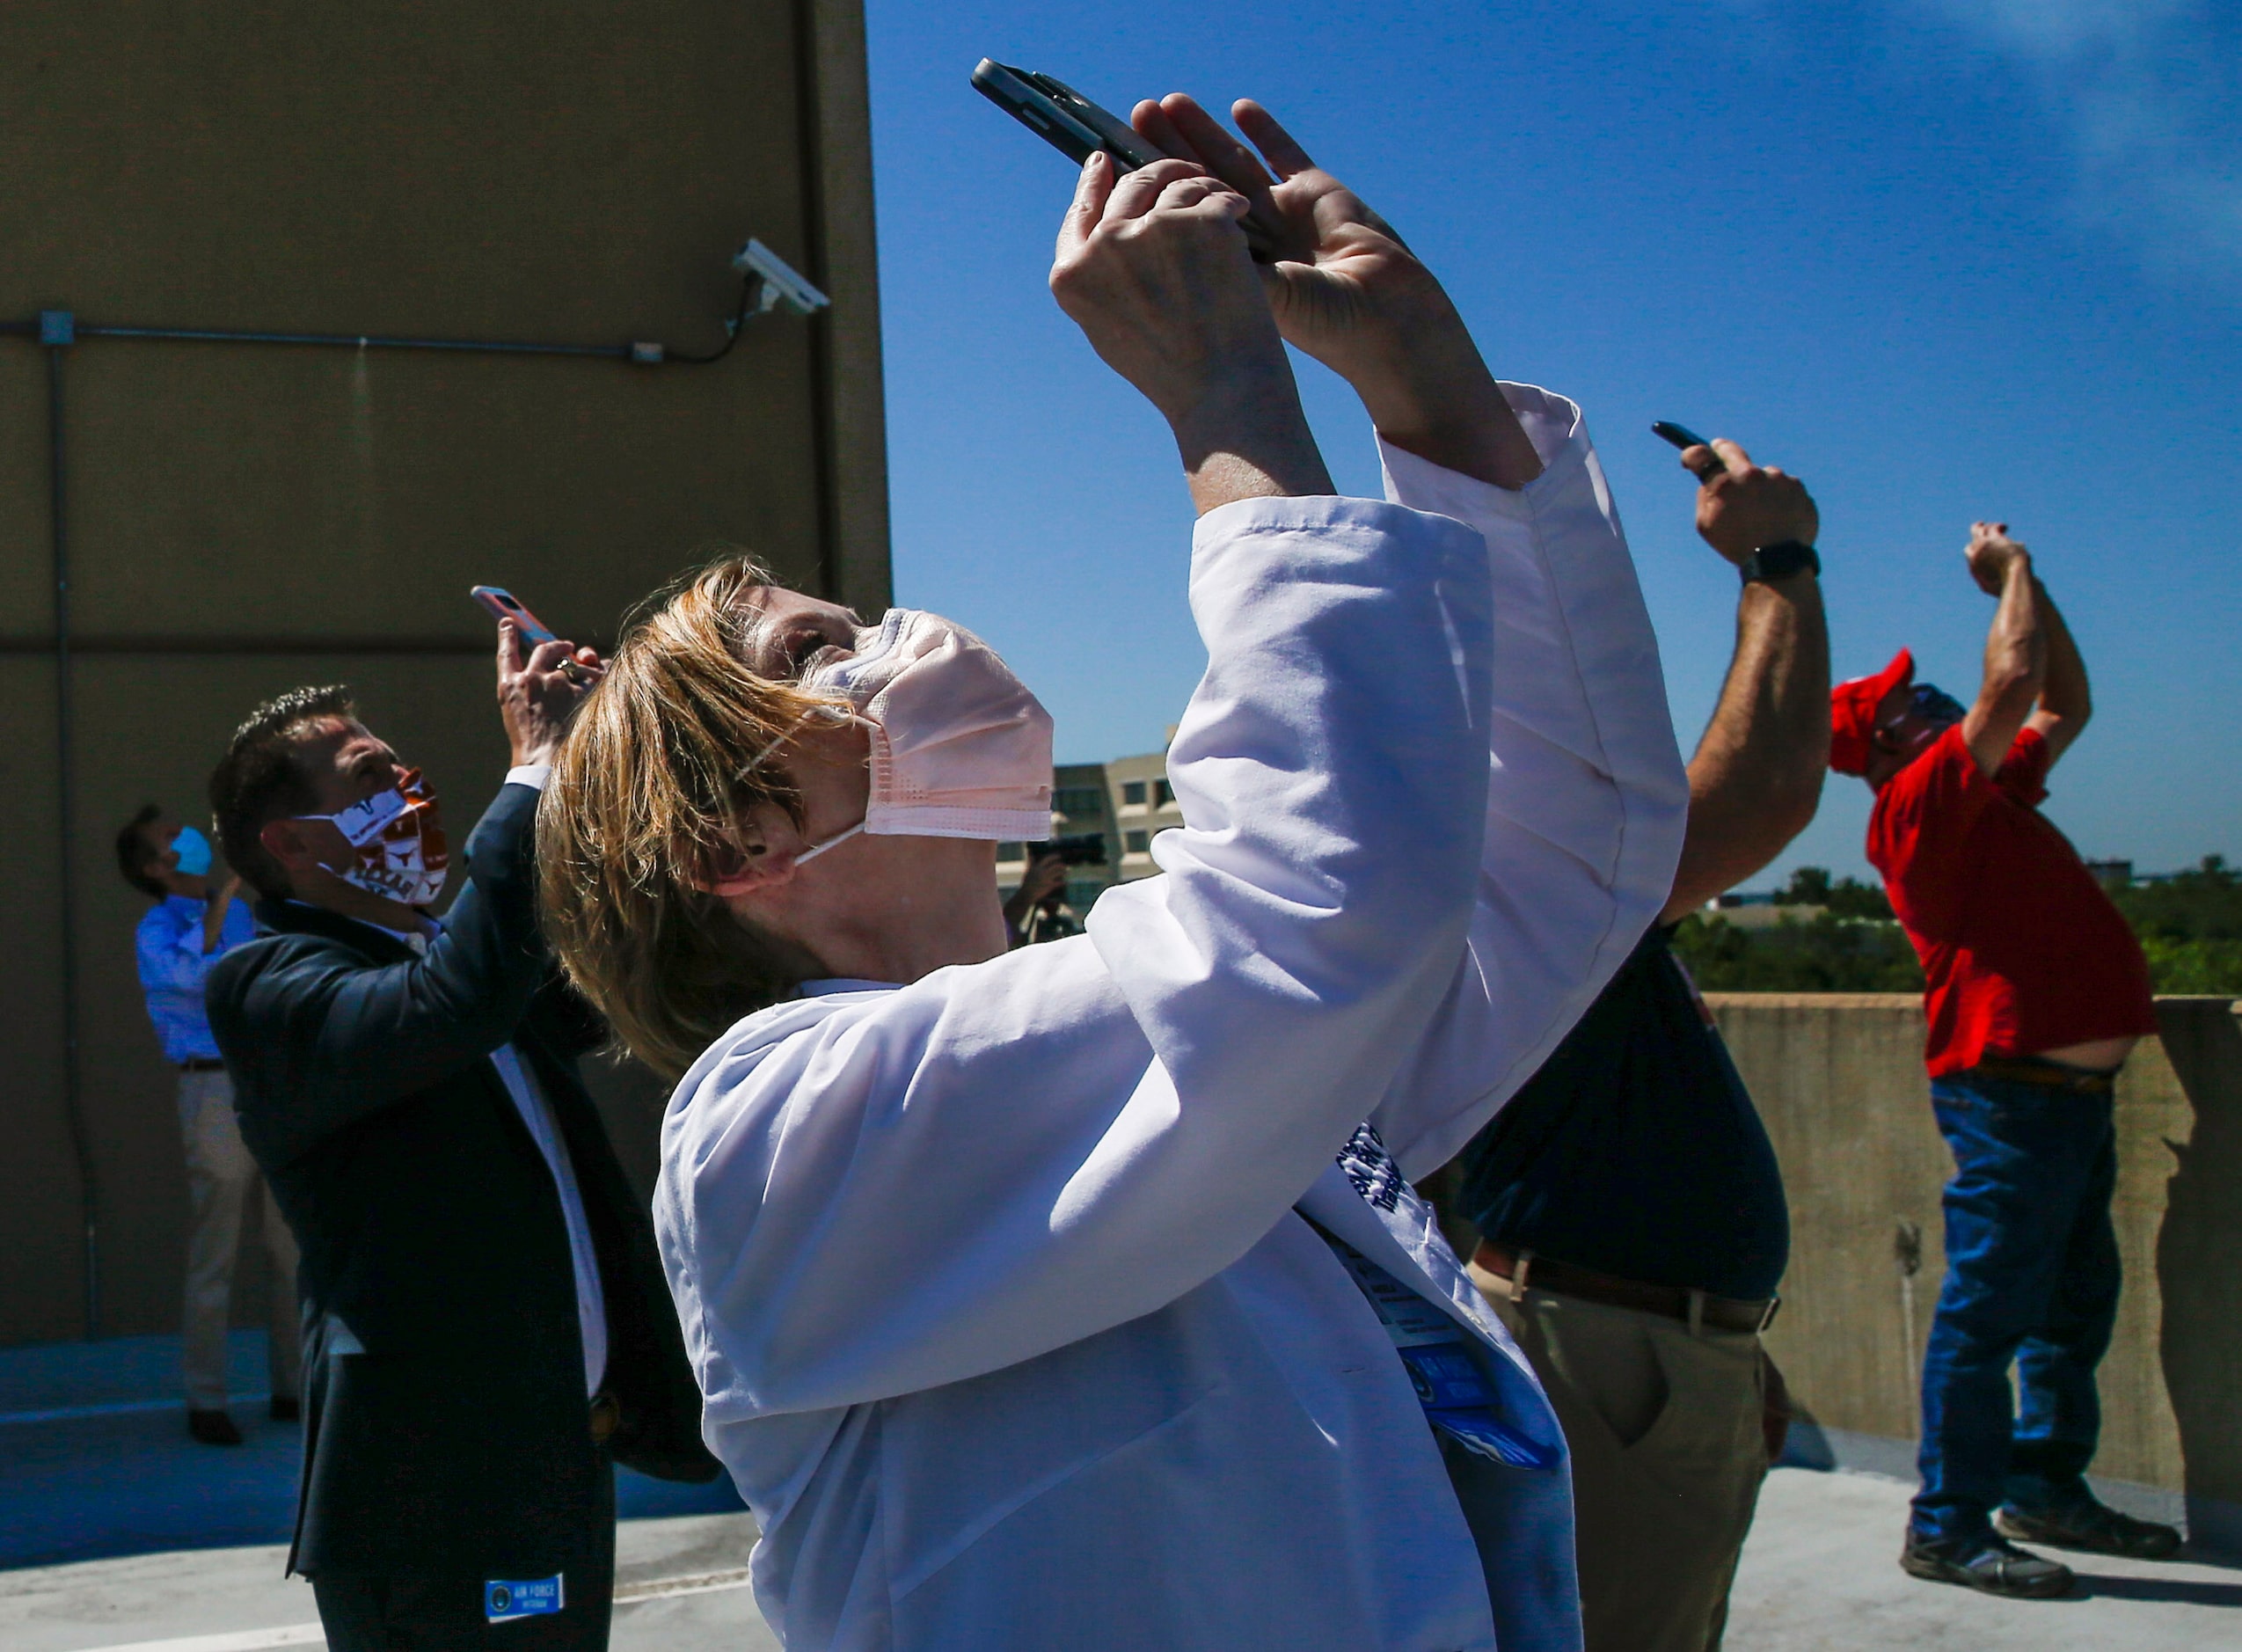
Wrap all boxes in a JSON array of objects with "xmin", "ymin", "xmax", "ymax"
[{"xmin": 751, "ymin": 608, "xmax": 1051, "ymax": 866}]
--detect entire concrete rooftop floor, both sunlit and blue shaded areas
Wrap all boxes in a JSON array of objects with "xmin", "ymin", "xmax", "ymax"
[{"xmin": 0, "ymin": 1334, "xmax": 2242, "ymax": 1652}]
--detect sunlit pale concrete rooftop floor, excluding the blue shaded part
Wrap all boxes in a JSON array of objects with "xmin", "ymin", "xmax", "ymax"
[{"xmin": 0, "ymin": 1468, "xmax": 2242, "ymax": 1652}]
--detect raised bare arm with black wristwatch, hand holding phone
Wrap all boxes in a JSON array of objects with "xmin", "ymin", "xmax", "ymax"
[{"xmin": 1659, "ymin": 442, "xmax": 1829, "ymax": 924}]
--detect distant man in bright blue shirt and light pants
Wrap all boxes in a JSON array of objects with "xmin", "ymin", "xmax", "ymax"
[{"xmin": 117, "ymin": 802, "xmax": 298, "ymax": 1446}]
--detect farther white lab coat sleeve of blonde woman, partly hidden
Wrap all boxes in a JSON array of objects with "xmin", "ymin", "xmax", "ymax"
[{"xmin": 1372, "ymin": 384, "xmax": 1688, "ymax": 1177}]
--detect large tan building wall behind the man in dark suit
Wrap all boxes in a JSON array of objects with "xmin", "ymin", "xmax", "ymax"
[{"xmin": 0, "ymin": 0, "xmax": 887, "ymax": 1345}]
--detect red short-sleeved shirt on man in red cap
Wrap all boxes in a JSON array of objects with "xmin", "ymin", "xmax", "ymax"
[{"xmin": 1867, "ymin": 724, "xmax": 2157, "ymax": 1078}]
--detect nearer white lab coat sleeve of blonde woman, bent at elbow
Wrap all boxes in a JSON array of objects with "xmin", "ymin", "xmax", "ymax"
[{"xmin": 654, "ymin": 498, "xmax": 1493, "ymax": 1426}]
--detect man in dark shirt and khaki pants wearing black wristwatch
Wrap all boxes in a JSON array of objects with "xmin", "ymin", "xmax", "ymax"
[{"xmin": 1455, "ymin": 442, "xmax": 1829, "ymax": 1652}]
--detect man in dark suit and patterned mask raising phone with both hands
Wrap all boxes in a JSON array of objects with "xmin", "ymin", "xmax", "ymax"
[{"xmin": 208, "ymin": 623, "xmax": 718, "ymax": 1652}]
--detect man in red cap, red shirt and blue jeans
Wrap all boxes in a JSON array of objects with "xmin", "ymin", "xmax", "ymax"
[{"xmin": 1829, "ymin": 523, "xmax": 2180, "ymax": 1596}]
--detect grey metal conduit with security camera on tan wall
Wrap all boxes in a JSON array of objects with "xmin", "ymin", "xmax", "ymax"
[{"xmin": 0, "ymin": 258, "xmax": 834, "ymax": 1341}]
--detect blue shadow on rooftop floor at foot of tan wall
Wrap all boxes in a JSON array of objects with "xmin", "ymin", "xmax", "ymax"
[{"xmin": 0, "ymin": 1332, "xmax": 740, "ymax": 1567}]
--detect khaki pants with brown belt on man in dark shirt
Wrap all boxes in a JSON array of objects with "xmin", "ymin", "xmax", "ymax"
[{"xmin": 1471, "ymin": 1267, "xmax": 1767, "ymax": 1652}]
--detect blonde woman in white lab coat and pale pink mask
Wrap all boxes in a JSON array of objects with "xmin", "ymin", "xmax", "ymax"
[{"xmin": 538, "ymin": 99, "xmax": 1686, "ymax": 1652}]
